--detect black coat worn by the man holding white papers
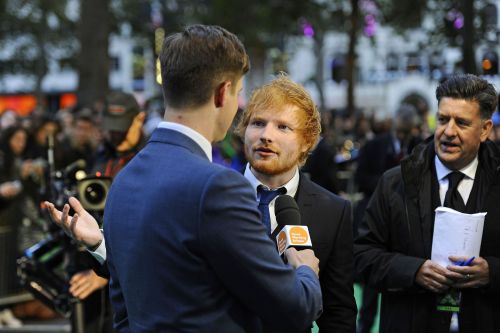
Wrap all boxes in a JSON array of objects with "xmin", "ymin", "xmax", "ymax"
[{"xmin": 354, "ymin": 138, "xmax": 500, "ymax": 333}]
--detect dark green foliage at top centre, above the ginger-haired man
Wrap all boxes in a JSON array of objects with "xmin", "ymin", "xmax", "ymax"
[{"xmin": 191, "ymin": 0, "xmax": 348, "ymax": 108}]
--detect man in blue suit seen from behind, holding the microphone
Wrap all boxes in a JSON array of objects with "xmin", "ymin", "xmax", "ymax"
[{"xmin": 49, "ymin": 25, "xmax": 322, "ymax": 333}]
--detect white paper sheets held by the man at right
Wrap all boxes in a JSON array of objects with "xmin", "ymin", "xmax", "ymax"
[{"xmin": 431, "ymin": 207, "xmax": 486, "ymax": 267}]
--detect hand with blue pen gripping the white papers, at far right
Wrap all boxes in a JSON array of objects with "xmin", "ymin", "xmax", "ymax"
[{"xmin": 447, "ymin": 256, "xmax": 490, "ymax": 289}]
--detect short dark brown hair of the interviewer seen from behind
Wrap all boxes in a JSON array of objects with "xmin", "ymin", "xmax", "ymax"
[{"xmin": 160, "ymin": 24, "xmax": 250, "ymax": 109}]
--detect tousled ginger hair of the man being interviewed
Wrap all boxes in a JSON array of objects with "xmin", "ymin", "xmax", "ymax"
[{"xmin": 235, "ymin": 74, "xmax": 321, "ymax": 165}]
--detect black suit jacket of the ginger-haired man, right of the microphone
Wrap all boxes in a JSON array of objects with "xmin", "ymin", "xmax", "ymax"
[{"xmin": 265, "ymin": 173, "xmax": 357, "ymax": 333}]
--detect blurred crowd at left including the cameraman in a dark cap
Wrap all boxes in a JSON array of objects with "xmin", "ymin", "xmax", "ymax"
[{"xmin": 0, "ymin": 92, "xmax": 146, "ymax": 331}]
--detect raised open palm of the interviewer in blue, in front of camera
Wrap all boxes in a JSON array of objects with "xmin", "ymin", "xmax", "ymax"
[{"xmin": 44, "ymin": 197, "xmax": 103, "ymax": 248}]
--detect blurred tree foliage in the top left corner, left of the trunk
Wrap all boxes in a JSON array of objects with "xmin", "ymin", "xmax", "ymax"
[{"xmin": 0, "ymin": 0, "xmax": 78, "ymax": 96}]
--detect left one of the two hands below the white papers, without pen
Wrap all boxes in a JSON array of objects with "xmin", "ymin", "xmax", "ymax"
[{"xmin": 415, "ymin": 260, "xmax": 462, "ymax": 293}]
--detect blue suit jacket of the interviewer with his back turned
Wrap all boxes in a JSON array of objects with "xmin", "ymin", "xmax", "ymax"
[{"xmin": 104, "ymin": 128, "xmax": 322, "ymax": 333}]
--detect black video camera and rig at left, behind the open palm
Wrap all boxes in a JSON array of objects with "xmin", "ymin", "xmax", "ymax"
[{"xmin": 18, "ymin": 137, "xmax": 111, "ymax": 333}]
